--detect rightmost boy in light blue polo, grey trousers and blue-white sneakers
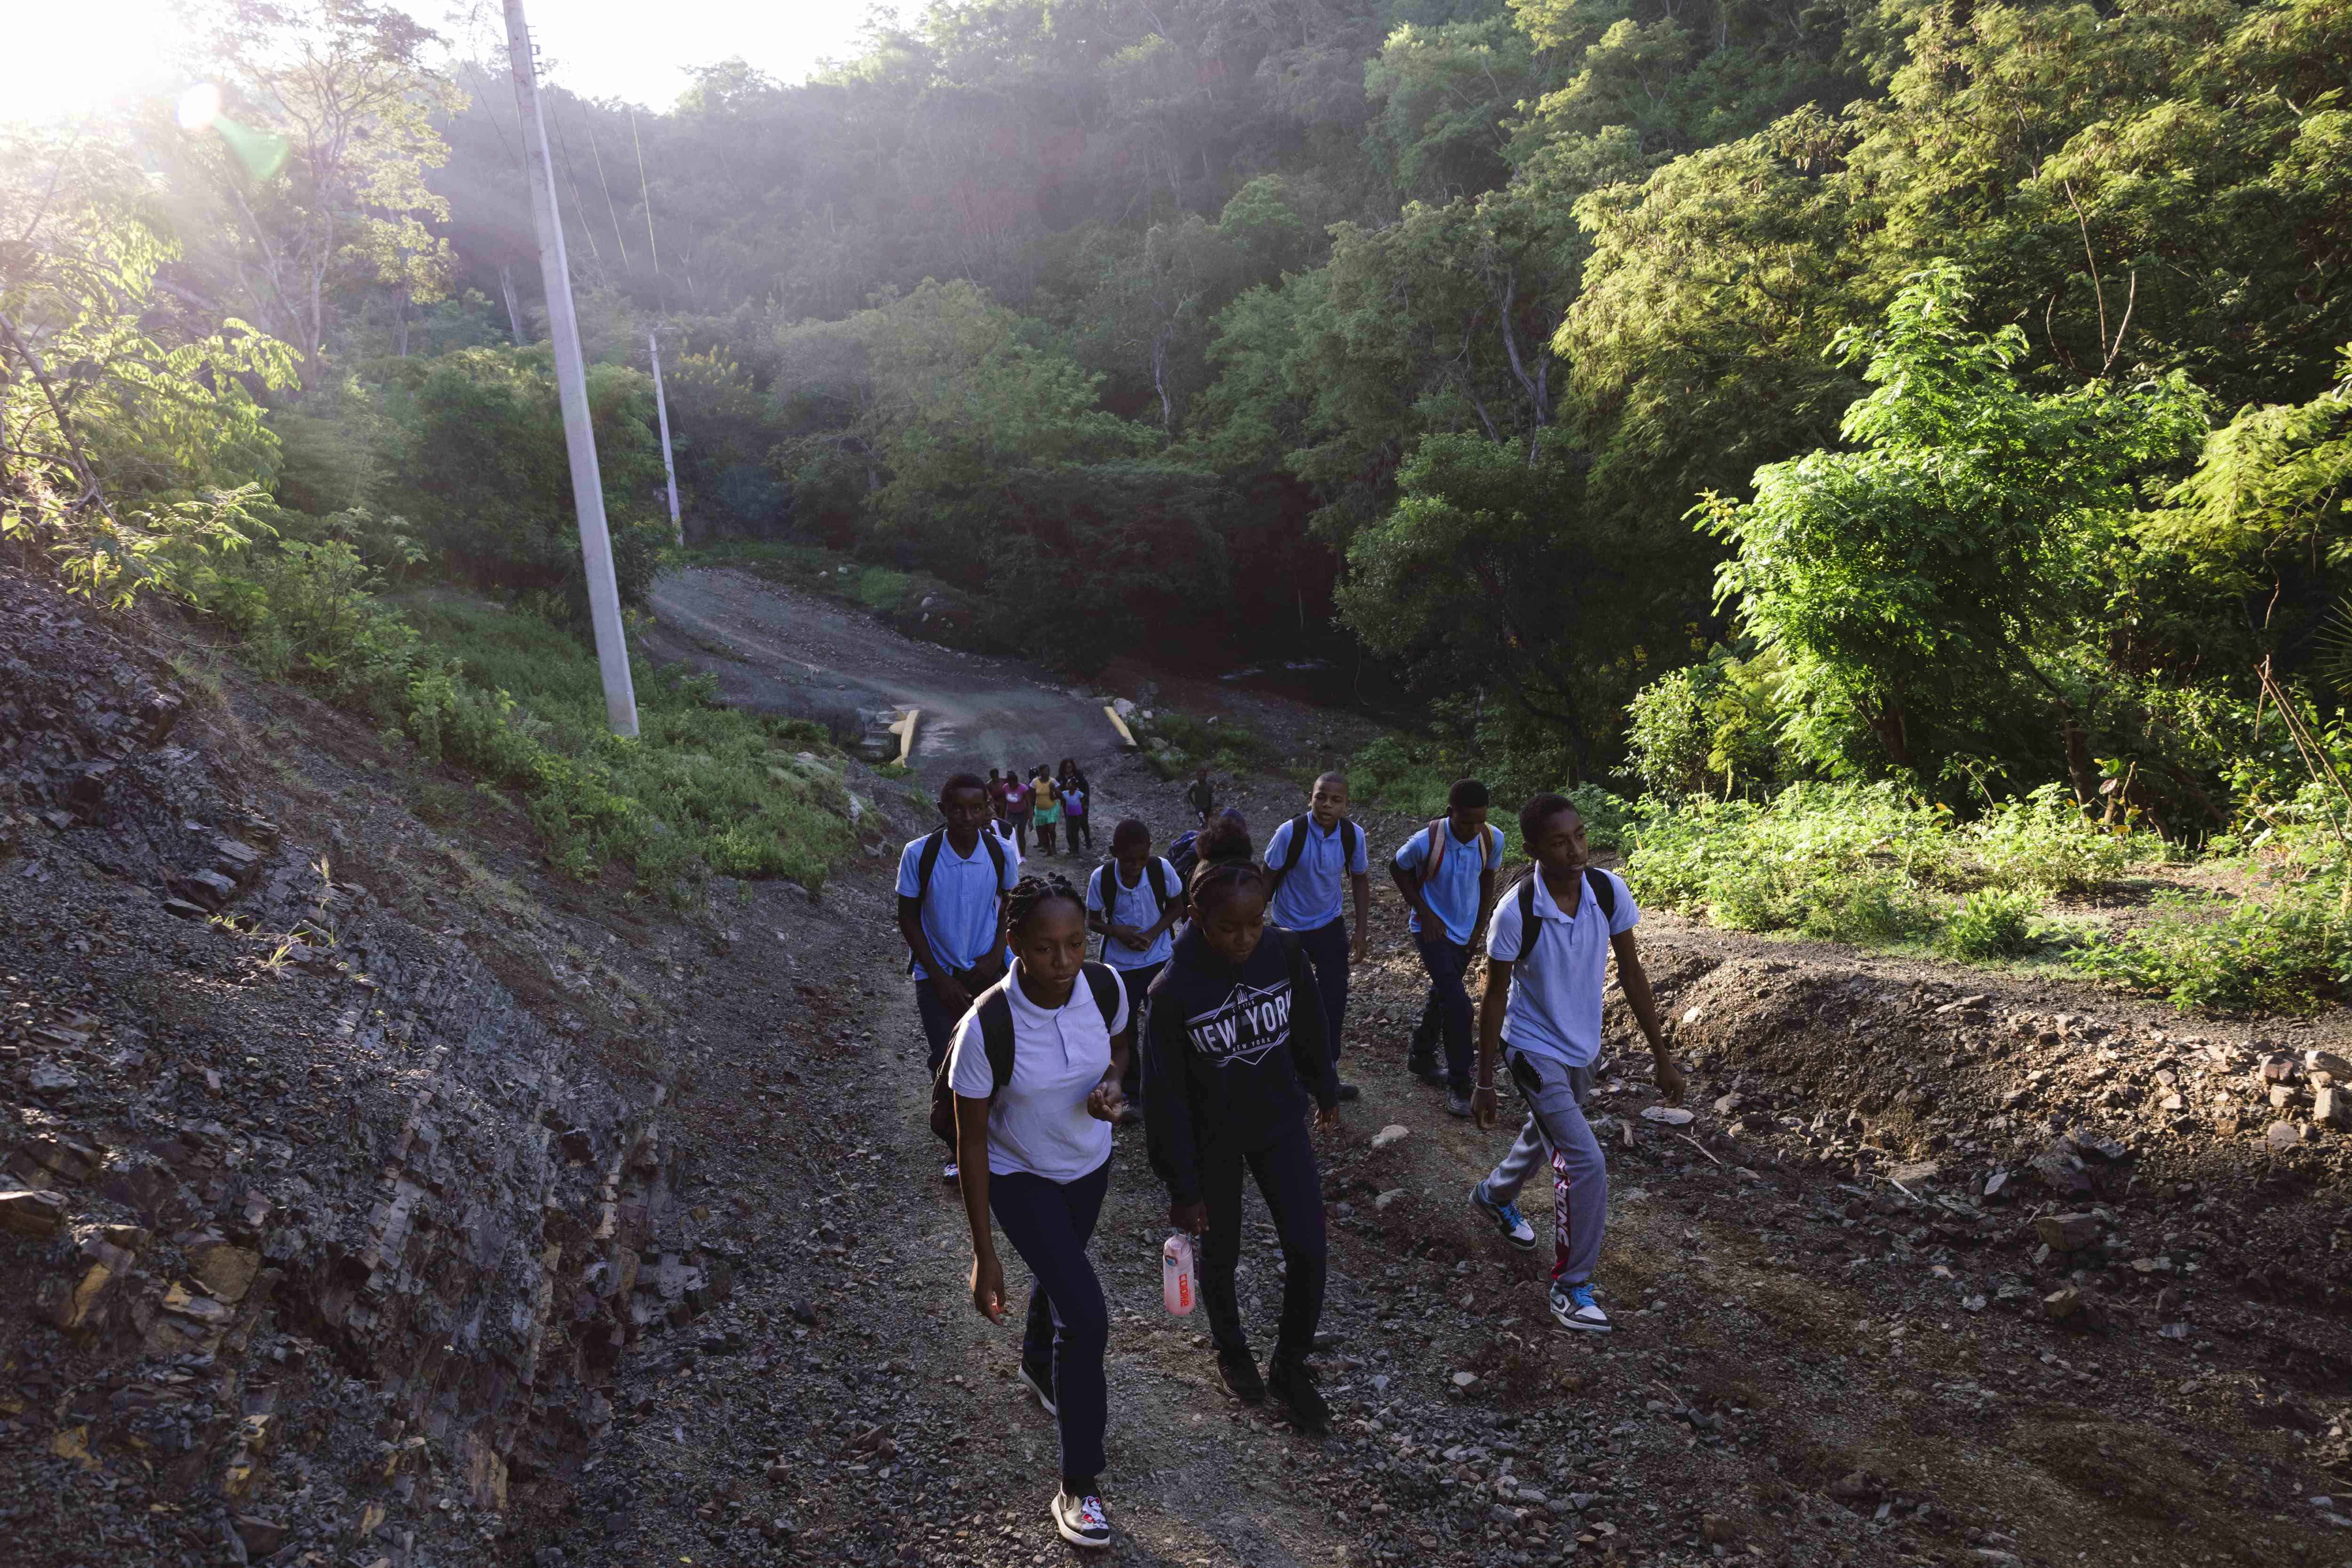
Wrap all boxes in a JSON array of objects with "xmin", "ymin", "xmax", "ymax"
[{"xmin": 1470, "ymin": 795, "xmax": 1684, "ymax": 1333}]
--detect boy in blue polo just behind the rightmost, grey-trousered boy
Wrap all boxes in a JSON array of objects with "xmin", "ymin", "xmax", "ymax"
[{"xmin": 1388, "ymin": 778, "xmax": 1503, "ymax": 1117}]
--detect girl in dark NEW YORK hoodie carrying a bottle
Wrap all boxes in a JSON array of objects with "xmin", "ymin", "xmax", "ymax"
[{"xmin": 1143, "ymin": 825, "xmax": 1338, "ymax": 1432}]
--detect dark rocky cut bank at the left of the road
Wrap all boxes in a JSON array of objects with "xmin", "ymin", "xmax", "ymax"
[{"xmin": 0, "ymin": 571, "xmax": 727, "ymax": 1563}]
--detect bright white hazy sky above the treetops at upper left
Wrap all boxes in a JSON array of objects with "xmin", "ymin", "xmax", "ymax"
[{"xmin": 0, "ymin": 0, "xmax": 898, "ymax": 120}]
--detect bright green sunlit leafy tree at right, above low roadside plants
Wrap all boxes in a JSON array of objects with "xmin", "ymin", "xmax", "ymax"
[{"xmin": 1698, "ymin": 263, "xmax": 2206, "ymax": 797}]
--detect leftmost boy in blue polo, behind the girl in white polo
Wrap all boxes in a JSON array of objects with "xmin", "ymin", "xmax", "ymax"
[{"xmin": 898, "ymin": 773, "xmax": 1021, "ymax": 1182}]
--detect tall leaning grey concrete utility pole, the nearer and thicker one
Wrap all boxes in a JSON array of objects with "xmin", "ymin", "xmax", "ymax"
[{"xmin": 506, "ymin": 0, "xmax": 637, "ymax": 736}]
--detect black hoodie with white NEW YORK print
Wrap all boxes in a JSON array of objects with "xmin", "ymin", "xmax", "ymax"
[{"xmin": 1143, "ymin": 926, "xmax": 1338, "ymax": 1203}]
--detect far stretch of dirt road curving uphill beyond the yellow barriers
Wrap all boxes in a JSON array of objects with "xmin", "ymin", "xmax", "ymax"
[{"xmin": 654, "ymin": 566, "xmax": 1120, "ymax": 785}]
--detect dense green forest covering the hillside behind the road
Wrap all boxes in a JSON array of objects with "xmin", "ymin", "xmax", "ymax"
[{"xmin": 0, "ymin": 0, "xmax": 2352, "ymax": 837}]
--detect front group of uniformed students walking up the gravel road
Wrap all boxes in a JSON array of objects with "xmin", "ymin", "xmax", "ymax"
[{"xmin": 898, "ymin": 773, "xmax": 1684, "ymax": 1547}]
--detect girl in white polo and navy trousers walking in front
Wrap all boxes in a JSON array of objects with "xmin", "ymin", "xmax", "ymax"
[{"xmin": 934, "ymin": 877, "xmax": 1131, "ymax": 1547}]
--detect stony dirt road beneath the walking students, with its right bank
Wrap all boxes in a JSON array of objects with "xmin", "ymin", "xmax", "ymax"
[{"xmin": 567, "ymin": 585, "xmax": 2352, "ymax": 1568}]
